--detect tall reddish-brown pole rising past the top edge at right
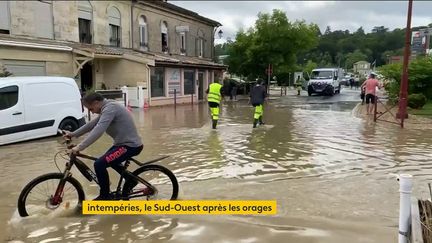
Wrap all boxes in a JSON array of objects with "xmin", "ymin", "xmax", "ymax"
[{"xmin": 396, "ymin": 0, "xmax": 412, "ymax": 128}]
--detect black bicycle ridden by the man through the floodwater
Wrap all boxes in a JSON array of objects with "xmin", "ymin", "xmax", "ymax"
[{"xmin": 18, "ymin": 131, "xmax": 179, "ymax": 217}]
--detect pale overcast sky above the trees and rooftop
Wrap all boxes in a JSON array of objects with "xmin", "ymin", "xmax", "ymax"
[{"xmin": 168, "ymin": 0, "xmax": 432, "ymax": 43}]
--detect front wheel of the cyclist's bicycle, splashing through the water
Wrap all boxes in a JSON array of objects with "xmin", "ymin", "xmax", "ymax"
[{"xmin": 18, "ymin": 173, "xmax": 85, "ymax": 217}]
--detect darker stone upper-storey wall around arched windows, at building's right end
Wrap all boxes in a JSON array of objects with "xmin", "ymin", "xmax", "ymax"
[{"xmin": 133, "ymin": 5, "xmax": 213, "ymax": 59}]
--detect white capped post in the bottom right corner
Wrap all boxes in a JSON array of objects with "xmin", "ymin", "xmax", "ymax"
[{"xmin": 399, "ymin": 174, "xmax": 412, "ymax": 243}]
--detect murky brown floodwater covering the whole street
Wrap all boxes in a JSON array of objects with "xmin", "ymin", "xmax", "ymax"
[{"xmin": 0, "ymin": 90, "xmax": 432, "ymax": 243}]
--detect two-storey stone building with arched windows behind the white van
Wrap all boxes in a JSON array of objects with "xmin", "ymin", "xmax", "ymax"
[{"xmin": 0, "ymin": 0, "xmax": 225, "ymax": 105}]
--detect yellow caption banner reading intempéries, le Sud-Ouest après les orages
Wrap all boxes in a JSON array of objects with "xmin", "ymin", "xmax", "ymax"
[{"xmin": 82, "ymin": 200, "xmax": 277, "ymax": 215}]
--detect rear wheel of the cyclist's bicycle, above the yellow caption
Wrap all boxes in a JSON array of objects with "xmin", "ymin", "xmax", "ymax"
[{"xmin": 122, "ymin": 165, "xmax": 179, "ymax": 200}]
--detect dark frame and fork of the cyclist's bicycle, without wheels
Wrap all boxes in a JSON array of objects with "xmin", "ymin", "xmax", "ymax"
[{"xmin": 52, "ymin": 154, "xmax": 169, "ymax": 205}]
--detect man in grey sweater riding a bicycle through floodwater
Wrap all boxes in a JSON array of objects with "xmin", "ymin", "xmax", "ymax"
[{"xmin": 64, "ymin": 93, "xmax": 143, "ymax": 200}]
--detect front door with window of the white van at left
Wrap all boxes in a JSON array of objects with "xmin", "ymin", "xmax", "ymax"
[{"xmin": 0, "ymin": 84, "xmax": 25, "ymax": 144}]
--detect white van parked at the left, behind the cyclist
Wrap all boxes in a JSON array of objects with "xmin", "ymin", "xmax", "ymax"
[{"xmin": 0, "ymin": 76, "xmax": 85, "ymax": 145}]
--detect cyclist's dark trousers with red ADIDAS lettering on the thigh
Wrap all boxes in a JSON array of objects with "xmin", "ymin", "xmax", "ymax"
[{"xmin": 94, "ymin": 145, "xmax": 143, "ymax": 197}]
